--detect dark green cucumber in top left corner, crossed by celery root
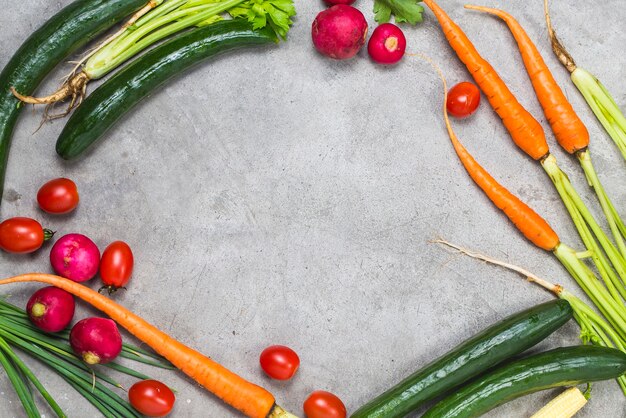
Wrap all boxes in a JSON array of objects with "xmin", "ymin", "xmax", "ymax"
[{"xmin": 0, "ymin": 0, "xmax": 147, "ymax": 206}]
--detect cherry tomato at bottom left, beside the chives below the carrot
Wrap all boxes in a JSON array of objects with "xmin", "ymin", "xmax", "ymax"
[{"xmin": 128, "ymin": 380, "xmax": 176, "ymax": 417}]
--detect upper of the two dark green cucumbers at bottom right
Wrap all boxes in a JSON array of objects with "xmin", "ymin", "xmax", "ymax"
[{"xmin": 352, "ymin": 299, "xmax": 573, "ymax": 418}]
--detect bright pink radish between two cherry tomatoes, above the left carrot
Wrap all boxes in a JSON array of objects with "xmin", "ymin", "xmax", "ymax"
[{"xmin": 50, "ymin": 234, "xmax": 100, "ymax": 282}]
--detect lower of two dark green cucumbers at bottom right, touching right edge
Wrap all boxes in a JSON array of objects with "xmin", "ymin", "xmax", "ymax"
[{"xmin": 422, "ymin": 345, "xmax": 626, "ymax": 418}]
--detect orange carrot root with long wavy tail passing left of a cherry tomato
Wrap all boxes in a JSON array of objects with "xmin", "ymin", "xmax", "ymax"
[{"xmin": 426, "ymin": 60, "xmax": 560, "ymax": 251}]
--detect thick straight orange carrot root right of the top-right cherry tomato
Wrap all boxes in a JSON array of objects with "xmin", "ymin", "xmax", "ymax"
[{"xmin": 424, "ymin": 0, "xmax": 550, "ymax": 160}]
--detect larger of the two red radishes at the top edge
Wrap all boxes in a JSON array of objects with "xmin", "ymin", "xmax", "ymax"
[{"xmin": 311, "ymin": 4, "xmax": 367, "ymax": 60}]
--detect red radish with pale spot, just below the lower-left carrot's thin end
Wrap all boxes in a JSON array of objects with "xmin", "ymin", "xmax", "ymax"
[{"xmin": 26, "ymin": 286, "xmax": 74, "ymax": 332}]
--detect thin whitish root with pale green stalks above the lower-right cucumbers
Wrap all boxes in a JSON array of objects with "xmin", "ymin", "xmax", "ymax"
[{"xmin": 434, "ymin": 239, "xmax": 626, "ymax": 396}]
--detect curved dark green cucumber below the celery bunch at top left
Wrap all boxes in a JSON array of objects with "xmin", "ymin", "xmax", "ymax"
[{"xmin": 56, "ymin": 19, "xmax": 277, "ymax": 159}]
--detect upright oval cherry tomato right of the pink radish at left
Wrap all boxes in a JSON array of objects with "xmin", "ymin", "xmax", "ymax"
[{"xmin": 100, "ymin": 241, "xmax": 135, "ymax": 292}]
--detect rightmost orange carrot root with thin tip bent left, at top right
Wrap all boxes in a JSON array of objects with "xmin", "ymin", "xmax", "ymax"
[{"xmin": 465, "ymin": 5, "xmax": 589, "ymax": 154}]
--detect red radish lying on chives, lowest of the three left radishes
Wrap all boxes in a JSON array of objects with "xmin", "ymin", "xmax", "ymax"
[{"xmin": 70, "ymin": 318, "xmax": 122, "ymax": 364}]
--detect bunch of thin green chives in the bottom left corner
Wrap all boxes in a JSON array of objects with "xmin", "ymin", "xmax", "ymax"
[{"xmin": 0, "ymin": 298, "xmax": 173, "ymax": 418}]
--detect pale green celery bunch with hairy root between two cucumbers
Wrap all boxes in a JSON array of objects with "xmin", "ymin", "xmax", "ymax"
[{"xmin": 12, "ymin": 0, "xmax": 296, "ymax": 112}]
